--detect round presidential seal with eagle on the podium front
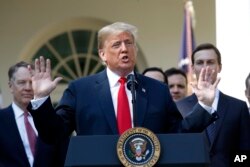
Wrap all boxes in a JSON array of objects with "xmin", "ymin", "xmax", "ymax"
[{"xmin": 116, "ymin": 127, "xmax": 161, "ymax": 167}]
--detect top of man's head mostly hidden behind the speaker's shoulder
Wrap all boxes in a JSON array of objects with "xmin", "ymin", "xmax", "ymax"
[{"xmin": 142, "ymin": 67, "xmax": 168, "ymax": 84}]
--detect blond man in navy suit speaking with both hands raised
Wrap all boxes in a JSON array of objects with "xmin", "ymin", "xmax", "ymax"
[{"xmin": 28, "ymin": 22, "xmax": 219, "ymax": 164}]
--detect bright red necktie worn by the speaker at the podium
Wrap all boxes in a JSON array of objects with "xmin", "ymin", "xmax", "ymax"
[{"xmin": 117, "ymin": 77, "xmax": 131, "ymax": 134}]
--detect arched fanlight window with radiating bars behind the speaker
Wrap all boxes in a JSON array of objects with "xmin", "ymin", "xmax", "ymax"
[{"xmin": 21, "ymin": 18, "xmax": 147, "ymax": 102}]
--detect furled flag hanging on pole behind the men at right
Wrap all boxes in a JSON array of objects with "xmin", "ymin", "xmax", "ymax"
[{"xmin": 178, "ymin": 0, "xmax": 195, "ymax": 93}]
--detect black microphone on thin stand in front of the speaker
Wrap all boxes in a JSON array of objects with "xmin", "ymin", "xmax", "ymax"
[{"xmin": 127, "ymin": 74, "xmax": 138, "ymax": 127}]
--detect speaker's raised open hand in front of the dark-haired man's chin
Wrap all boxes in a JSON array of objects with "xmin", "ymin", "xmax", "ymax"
[{"xmin": 191, "ymin": 66, "xmax": 220, "ymax": 106}]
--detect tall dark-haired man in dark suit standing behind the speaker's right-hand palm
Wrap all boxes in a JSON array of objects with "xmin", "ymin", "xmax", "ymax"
[{"xmin": 177, "ymin": 43, "xmax": 250, "ymax": 167}]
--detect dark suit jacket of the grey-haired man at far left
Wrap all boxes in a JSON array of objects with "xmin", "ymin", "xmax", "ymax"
[{"xmin": 0, "ymin": 105, "xmax": 63, "ymax": 167}]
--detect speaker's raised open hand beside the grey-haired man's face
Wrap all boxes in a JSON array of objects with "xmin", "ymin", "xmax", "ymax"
[{"xmin": 29, "ymin": 56, "xmax": 62, "ymax": 99}]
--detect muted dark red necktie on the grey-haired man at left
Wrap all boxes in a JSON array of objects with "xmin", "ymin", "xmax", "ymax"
[{"xmin": 24, "ymin": 112, "xmax": 36, "ymax": 156}]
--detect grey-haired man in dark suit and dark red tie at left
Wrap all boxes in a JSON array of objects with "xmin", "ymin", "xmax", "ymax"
[{"xmin": 0, "ymin": 62, "xmax": 63, "ymax": 167}]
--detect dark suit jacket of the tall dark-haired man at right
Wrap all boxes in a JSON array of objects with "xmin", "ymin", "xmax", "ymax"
[{"xmin": 177, "ymin": 92, "xmax": 250, "ymax": 167}]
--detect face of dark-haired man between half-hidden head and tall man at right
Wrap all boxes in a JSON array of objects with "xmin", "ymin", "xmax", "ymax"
[{"xmin": 165, "ymin": 68, "xmax": 188, "ymax": 101}]
